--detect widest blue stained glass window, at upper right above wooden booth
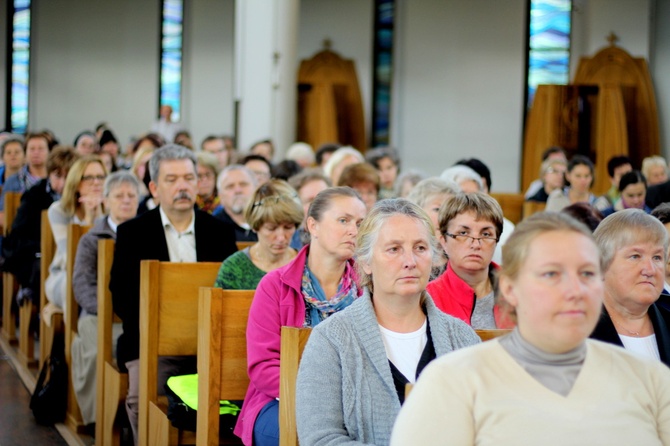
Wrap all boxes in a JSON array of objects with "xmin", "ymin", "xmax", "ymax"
[{"xmin": 528, "ymin": 0, "xmax": 572, "ymax": 107}]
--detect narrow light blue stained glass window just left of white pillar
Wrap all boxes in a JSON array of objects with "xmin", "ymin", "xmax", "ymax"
[{"xmin": 160, "ymin": 0, "xmax": 184, "ymax": 122}]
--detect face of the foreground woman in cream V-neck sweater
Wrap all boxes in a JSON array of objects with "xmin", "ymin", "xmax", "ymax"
[{"xmin": 500, "ymin": 231, "xmax": 603, "ymax": 353}]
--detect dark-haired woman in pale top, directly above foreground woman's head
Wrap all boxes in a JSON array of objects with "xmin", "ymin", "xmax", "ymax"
[{"xmin": 546, "ymin": 155, "xmax": 596, "ymax": 211}]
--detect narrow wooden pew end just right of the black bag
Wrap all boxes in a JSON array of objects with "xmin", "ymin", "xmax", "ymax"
[{"xmin": 65, "ymin": 223, "xmax": 91, "ymax": 432}]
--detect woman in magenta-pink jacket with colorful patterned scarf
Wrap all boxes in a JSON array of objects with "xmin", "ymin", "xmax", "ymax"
[{"xmin": 235, "ymin": 187, "xmax": 366, "ymax": 446}]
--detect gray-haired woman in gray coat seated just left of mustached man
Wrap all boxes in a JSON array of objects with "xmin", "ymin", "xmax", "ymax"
[{"xmin": 71, "ymin": 171, "xmax": 140, "ymax": 424}]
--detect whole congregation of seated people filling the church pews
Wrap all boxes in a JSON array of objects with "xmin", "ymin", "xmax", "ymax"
[{"xmin": 0, "ymin": 124, "xmax": 670, "ymax": 446}]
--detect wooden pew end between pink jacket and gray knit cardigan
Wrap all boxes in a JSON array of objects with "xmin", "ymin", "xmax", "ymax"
[{"xmin": 279, "ymin": 327, "xmax": 312, "ymax": 446}]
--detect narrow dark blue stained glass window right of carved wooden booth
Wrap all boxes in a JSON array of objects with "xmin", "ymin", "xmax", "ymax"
[{"xmin": 372, "ymin": 0, "xmax": 395, "ymax": 147}]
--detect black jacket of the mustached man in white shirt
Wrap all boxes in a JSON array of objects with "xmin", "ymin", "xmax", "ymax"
[{"xmin": 109, "ymin": 208, "xmax": 237, "ymax": 369}]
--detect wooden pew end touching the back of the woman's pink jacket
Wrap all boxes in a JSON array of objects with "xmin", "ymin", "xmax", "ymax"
[{"xmin": 196, "ymin": 288, "xmax": 254, "ymax": 446}]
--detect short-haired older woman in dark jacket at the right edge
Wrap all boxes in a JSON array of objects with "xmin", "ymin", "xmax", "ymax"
[{"xmin": 591, "ymin": 209, "xmax": 670, "ymax": 366}]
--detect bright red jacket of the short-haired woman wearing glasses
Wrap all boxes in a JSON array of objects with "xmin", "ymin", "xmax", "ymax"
[{"xmin": 426, "ymin": 262, "xmax": 514, "ymax": 328}]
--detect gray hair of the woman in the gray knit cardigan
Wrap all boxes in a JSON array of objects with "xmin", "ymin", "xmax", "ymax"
[{"xmin": 355, "ymin": 198, "xmax": 439, "ymax": 292}]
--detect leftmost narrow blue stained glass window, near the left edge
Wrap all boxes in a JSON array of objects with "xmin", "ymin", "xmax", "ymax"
[{"xmin": 10, "ymin": 0, "xmax": 30, "ymax": 133}]
